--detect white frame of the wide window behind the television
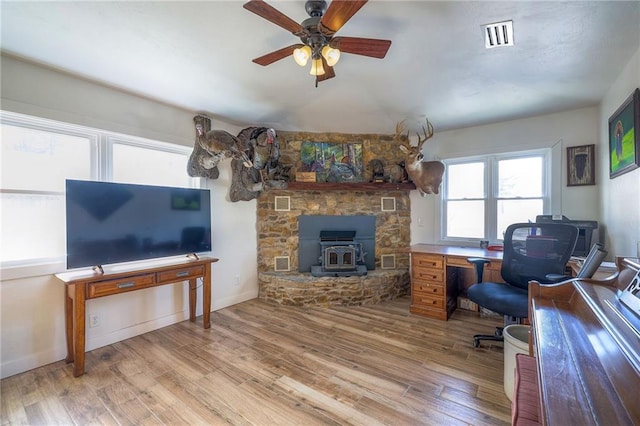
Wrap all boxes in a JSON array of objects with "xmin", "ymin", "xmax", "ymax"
[{"xmin": 0, "ymin": 110, "xmax": 198, "ymax": 274}]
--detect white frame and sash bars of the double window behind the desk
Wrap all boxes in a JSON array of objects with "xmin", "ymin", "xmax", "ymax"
[{"xmin": 438, "ymin": 148, "xmax": 553, "ymax": 244}]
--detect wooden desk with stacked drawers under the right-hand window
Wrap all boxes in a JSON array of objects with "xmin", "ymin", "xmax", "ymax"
[{"xmin": 409, "ymin": 244, "xmax": 503, "ymax": 321}]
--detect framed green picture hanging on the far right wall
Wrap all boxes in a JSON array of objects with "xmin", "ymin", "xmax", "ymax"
[{"xmin": 609, "ymin": 89, "xmax": 640, "ymax": 179}]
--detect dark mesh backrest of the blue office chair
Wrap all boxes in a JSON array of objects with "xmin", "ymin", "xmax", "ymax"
[{"xmin": 500, "ymin": 223, "xmax": 579, "ymax": 289}]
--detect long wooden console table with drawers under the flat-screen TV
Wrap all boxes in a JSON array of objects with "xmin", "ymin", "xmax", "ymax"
[{"xmin": 56, "ymin": 257, "xmax": 218, "ymax": 377}]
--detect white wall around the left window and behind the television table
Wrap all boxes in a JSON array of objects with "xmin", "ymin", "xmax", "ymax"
[{"xmin": 0, "ymin": 55, "xmax": 259, "ymax": 377}]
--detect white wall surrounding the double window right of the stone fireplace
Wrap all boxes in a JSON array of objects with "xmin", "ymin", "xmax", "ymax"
[{"xmin": 411, "ymin": 107, "xmax": 608, "ymax": 244}]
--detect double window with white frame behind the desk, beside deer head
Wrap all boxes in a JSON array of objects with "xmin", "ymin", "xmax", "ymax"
[{"xmin": 442, "ymin": 150, "xmax": 550, "ymax": 241}]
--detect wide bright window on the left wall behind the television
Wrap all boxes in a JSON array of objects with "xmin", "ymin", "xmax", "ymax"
[{"xmin": 0, "ymin": 111, "xmax": 198, "ymax": 267}]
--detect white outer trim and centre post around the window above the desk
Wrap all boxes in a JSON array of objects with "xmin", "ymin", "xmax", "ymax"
[{"xmin": 435, "ymin": 148, "xmax": 561, "ymax": 246}]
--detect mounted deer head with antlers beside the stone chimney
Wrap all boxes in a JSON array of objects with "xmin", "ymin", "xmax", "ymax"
[{"xmin": 395, "ymin": 119, "xmax": 444, "ymax": 197}]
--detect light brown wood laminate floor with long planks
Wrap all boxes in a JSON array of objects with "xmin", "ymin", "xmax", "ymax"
[{"xmin": 0, "ymin": 297, "xmax": 510, "ymax": 426}]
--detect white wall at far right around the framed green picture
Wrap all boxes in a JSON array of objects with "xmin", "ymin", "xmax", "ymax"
[{"xmin": 598, "ymin": 49, "xmax": 640, "ymax": 256}]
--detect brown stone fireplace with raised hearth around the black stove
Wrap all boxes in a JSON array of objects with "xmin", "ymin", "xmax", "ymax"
[{"xmin": 257, "ymin": 132, "xmax": 411, "ymax": 306}]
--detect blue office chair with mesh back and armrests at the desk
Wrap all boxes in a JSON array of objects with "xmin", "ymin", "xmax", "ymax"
[{"xmin": 467, "ymin": 223, "xmax": 578, "ymax": 348}]
